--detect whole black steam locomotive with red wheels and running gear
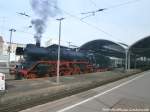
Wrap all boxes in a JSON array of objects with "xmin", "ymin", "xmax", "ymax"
[{"xmin": 14, "ymin": 44, "xmax": 108, "ymax": 79}]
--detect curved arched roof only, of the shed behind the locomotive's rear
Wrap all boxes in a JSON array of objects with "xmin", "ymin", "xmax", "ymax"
[{"xmin": 79, "ymin": 39, "xmax": 125, "ymax": 58}]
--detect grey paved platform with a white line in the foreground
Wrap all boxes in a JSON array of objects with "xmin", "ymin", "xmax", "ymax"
[{"xmin": 21, "ymin": 71, "xmax": 150, "ymax": 112}]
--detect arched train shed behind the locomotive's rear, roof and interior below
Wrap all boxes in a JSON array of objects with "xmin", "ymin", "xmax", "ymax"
[{"xmin": 79, "ymin": 39, "xmax": 125, "ymax": 67}]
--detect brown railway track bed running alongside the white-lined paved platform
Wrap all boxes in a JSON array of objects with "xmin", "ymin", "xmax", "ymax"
[{"xmin": 0, "ymin": 72, "xmax": 139, "ymax": 112}]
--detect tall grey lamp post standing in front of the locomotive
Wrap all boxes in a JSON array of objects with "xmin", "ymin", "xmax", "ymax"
[{"xmin": 56, "ymin": 18, "xmax": 64, "ymax": 84}]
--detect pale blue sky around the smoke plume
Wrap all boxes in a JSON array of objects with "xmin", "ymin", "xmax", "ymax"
[{"xmin": 0, "ymin": 0, "xmax": 150, "ymax": 46}]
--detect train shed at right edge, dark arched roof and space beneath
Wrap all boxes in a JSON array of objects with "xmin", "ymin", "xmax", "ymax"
[{"xmin": 128, "ymin": 36, "xmax": 150, "ymax": 69}]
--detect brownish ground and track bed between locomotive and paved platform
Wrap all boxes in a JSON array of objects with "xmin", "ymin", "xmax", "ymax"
[{"xmin": 0, "ymin": 70, "xmax": 141, "ymax": 112}]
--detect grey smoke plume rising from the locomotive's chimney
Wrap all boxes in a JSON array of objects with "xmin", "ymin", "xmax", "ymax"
[{"xmin": 31, "ymin": 0, "xmax": 58, "ymax": 43}]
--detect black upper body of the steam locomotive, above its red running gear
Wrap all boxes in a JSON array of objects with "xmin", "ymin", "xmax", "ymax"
[{"xmin": 16, "ymin": 44, "xmax": 110, "ymax": 67}]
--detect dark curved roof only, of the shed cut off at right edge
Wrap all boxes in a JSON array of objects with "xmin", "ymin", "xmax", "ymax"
[{"xmin": 129, "ymin": 36, "xmax": 150, "ymax": 58}]
